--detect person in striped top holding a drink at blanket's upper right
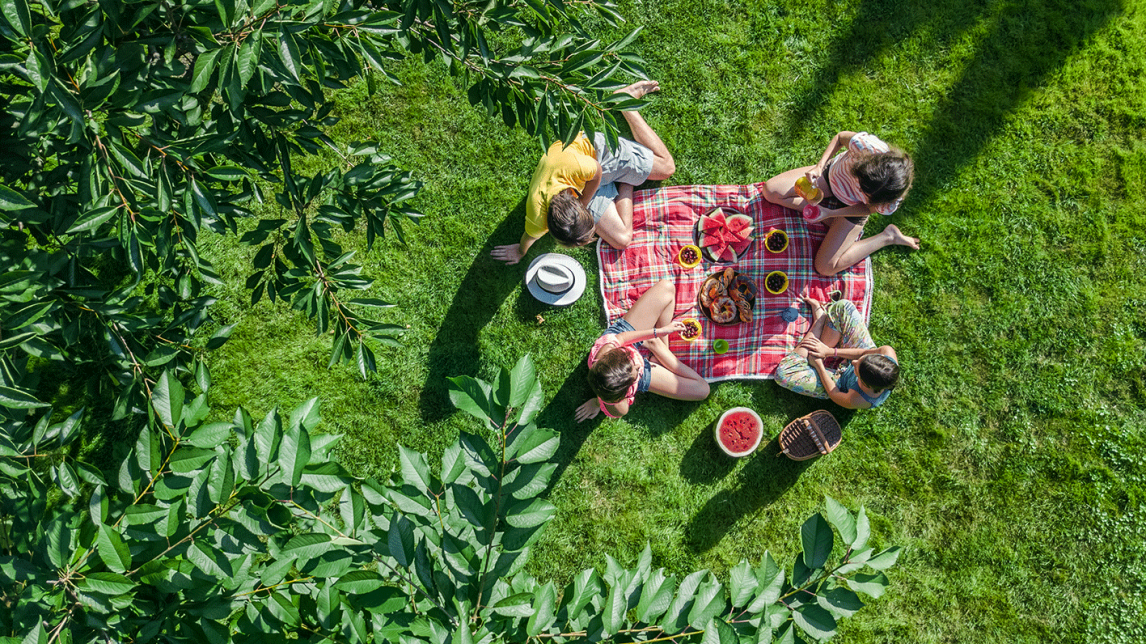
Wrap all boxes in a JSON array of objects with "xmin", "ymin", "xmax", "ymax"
[{"xmin": 764, "ymin": 132, "xmax": 919, "ymax": 275}]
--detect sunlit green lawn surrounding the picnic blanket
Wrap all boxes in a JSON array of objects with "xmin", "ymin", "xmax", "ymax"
[{"xmin": 194, "ymin": 0, "xmax": 1146, "ymax": 643}]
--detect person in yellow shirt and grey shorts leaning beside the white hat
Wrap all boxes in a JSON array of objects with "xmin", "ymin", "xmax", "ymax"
[{"xmin": 489, "ymin": 80, "xmax": 676, "ymax": 265}]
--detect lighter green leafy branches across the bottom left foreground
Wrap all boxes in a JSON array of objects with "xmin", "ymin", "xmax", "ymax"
[{"xmin": 0, "ymin": 356, "xmax": 898, "ymax": 644}]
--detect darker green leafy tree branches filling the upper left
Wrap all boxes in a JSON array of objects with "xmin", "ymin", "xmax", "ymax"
[{"xmin": 0, "ymin": 0, "xmax": 643, "ymax": 415}]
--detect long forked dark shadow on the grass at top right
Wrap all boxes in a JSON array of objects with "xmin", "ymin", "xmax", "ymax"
[{"xmin": 784, "ymin": 0, "xmax": 1123, "ymax": 215}]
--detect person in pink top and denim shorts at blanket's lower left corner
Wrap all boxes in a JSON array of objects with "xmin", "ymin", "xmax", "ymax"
[{"xmin": 575, "ymin": 280, "xmax": 708, "ymax": 423}]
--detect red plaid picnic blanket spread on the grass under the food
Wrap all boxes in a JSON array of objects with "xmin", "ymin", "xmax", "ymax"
[{"xmin": 597, "ymin": 183, "xmax": 872, "ymax": 382}]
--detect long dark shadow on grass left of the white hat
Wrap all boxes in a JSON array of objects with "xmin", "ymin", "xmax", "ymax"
[{"xmin": 418, "ymin": 197, "xmax": 554, "ymax": 423}]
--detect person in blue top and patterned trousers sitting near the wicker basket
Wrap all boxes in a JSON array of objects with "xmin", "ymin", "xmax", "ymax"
[{"xmin": 776, "ymin": 298, "xmax": 900, "ymax": 409}]
